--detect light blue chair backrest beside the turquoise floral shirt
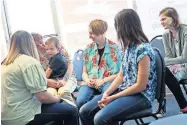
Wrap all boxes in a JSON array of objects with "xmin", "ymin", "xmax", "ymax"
[{"xmin": 73, "ymin": 49, "xmax": 84, "ymax": 81}]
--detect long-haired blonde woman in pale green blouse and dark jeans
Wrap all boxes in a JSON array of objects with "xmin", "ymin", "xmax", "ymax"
[{"xmin": 1, "ymin": 31, "xmax": 78, "ymax": 125}]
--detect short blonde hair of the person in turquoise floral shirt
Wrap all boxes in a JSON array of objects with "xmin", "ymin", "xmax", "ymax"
[{"xmin": 89, "ymin": 19, "xmax": 108, "ymax": 35}]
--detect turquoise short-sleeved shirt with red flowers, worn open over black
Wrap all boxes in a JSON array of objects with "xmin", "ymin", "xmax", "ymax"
[{"xmin": 84, "ymin": 40, "xmax": 121, "ymax": 83}]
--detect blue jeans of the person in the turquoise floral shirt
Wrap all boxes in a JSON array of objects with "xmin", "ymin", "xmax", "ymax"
[{"xmin": 76, "ymin": 82, "xmax": 111, "ymax": 109}]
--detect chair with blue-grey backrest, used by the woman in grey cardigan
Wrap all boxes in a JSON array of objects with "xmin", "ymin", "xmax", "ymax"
[{"xmin": 150, "ymin": 35, "xmax": 187, "ymax": 94}]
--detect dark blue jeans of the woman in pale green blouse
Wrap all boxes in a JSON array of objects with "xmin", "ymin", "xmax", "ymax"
[{"xmin": 27, "ymin": 103, "xmax": 79, "ymax": 125}]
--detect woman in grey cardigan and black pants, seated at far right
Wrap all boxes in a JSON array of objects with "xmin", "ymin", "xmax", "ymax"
[{"xmin": 159, "ymin": 7, "xmax": 187, "ymax": 112}]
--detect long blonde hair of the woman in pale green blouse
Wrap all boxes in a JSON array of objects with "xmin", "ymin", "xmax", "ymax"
[{"xmin": 1, "ymin": 30, "xmax": 39, "ymax": 65}]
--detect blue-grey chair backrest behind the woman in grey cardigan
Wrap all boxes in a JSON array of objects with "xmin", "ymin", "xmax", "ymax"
[{"xmin": 150, "ymin": 35, "xmax": 165, "ymax": 57}]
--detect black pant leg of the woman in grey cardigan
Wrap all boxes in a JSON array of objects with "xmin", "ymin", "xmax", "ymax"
[{"xmin": 165, "ymin": 67, "xmax": 187, "ymax": 109}]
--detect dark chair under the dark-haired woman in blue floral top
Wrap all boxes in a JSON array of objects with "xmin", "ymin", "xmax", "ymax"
[{"xmin": 120, "ymin": 48, "xmax": 166, "ymax": 125}]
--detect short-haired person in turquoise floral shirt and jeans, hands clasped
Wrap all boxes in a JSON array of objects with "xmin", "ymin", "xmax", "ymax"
[{"xmin": 76, "ymin": 19, "xmax": 121, "ymax": 109}]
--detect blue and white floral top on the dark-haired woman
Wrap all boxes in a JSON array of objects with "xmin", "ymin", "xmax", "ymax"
[{"xmin": 119, "ymin": 43, "xmax": 157, "ymax": 103}]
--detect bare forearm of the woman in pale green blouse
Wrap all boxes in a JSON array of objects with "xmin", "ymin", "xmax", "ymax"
[{"xmin": 35, "ymin": 91, "xmax": 60, "ymax": 104}]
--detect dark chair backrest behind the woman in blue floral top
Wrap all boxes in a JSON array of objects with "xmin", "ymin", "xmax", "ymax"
[{"xmin": 153, "ymin": 48, "xmax": 165, "ymax": 101}]
